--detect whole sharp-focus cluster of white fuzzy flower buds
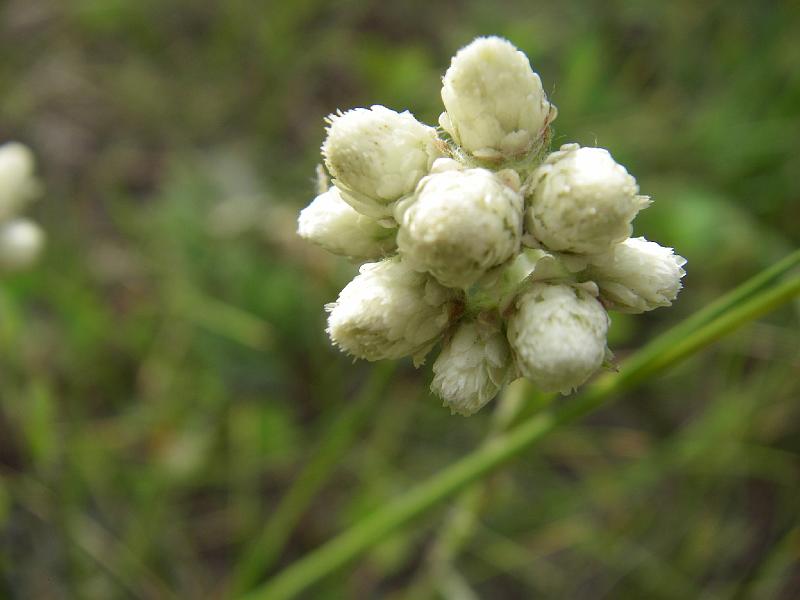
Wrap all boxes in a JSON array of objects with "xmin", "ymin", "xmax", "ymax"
[{"xmin": 298, "ymin": 37, "xmax": 686, "ymax": 415}]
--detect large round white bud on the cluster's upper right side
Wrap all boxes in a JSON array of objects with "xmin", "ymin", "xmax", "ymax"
[{"xmin": 525, "ymin": 144, "xmax": 650, "ymax": 254}]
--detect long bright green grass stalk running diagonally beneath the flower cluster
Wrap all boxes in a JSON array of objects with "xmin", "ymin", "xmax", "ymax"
[{"xmin": 247, "ymin": 252, "xmax": 800, "ymax": 600}]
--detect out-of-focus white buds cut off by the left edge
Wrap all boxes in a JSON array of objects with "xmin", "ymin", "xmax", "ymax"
[{"xmin": 0, "ymin": 142, "xmax": 44, "ymax": 271}]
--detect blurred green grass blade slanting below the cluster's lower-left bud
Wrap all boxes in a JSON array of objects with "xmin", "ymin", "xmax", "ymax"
[{"xmin": 230, "ymin": 361, "xmax": 397, "ymax": 596}]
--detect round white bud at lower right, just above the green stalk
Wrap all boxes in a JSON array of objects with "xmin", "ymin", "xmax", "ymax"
[{"xmin": 508, "ymin": 283, "xmax": 608, "ymax": 393}]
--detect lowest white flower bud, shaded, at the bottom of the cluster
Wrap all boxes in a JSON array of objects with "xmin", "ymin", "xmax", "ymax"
[{"xmin": 431, "ymin": 322, "xmax": 511, "ymax": 416}]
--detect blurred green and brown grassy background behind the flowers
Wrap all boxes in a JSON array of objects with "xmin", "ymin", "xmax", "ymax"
[{"xmin": 0, "ymin": 0, "xmax": 800, "ymax": 599}]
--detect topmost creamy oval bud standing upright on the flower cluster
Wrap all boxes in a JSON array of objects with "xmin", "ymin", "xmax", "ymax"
[{"xmin": 439, "ymin": 37, "xmax": 556, "ymax": 160}]
